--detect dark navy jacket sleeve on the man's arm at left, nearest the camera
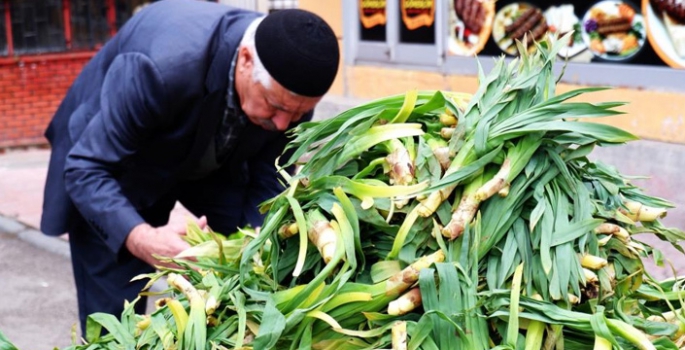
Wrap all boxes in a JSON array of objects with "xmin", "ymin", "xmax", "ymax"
[{"xmin": 64, "ymin": 53, "xmax": 166, "ymax": 254}]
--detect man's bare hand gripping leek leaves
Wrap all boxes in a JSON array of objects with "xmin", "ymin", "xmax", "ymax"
[{"xmin": 126, "ymin": 216, "xmax": 207, "ymax": 267}]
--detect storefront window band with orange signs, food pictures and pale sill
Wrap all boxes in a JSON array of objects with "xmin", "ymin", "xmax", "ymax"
[{"xmin": 343, "ymin": 0, "xmax": 685, "ymax": 91}]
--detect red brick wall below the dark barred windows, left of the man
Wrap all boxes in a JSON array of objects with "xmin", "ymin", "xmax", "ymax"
[{"xmin": 0, "ymin": 53, "xmax": 93, "ymax": 148}]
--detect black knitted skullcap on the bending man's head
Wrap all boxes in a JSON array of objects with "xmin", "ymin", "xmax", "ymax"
[{"xmin": 255, "ymin": 9, "xmax": 340, "ymax": 97}]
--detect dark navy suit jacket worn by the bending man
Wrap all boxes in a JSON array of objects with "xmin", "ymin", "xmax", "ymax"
[{"xmin": 41, "ymin": 0, "xmax": 304, "ymax": 253}]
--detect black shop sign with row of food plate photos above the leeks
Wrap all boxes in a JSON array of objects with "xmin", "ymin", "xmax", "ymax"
[{"xmin": 444, "ymin": 0, "xmax": 685, "ymax": 68}]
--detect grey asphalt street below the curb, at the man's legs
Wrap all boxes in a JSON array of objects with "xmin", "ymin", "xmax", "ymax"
[{"xmin": 0, "ymin": 227, "xmax": 78, "ymax": 350}]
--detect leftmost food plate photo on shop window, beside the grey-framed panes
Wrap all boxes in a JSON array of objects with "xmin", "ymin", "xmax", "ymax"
[{"xmin": 448, "ymin": 0, "xmax": 495, "ymax": 56}]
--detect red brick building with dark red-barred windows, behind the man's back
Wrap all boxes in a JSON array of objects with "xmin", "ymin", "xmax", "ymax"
[{"xmin": 0, "ymin": 0, "xmax": 149, "ymax": 148}]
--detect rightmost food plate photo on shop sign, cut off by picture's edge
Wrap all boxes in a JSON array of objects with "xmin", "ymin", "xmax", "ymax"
[{"xmin": 642, "ymin": 0, "xmax": 685, "ymax": 68}]
